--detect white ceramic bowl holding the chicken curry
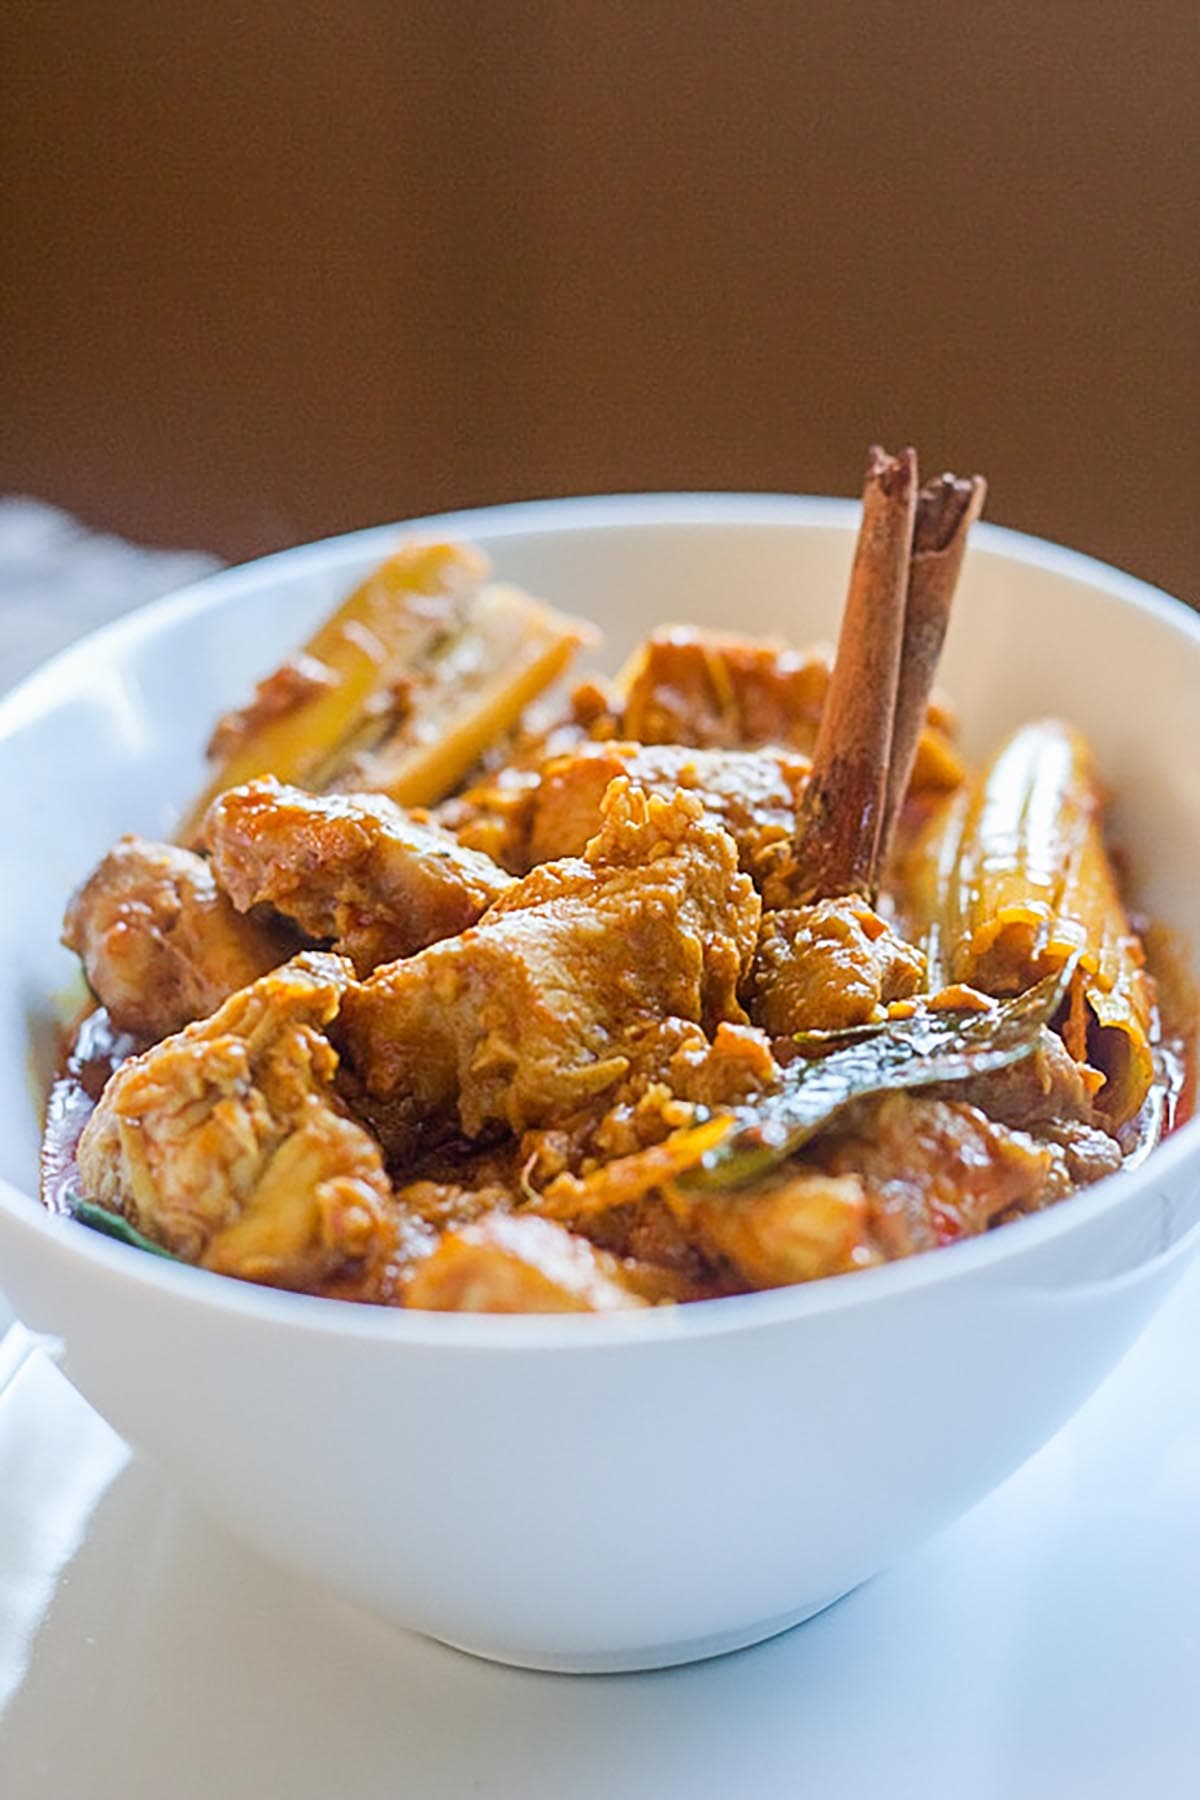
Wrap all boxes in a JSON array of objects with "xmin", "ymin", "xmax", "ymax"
[{"xmin": 0, "ymin": 495, "xmax": 1200, "ymax": 1669}]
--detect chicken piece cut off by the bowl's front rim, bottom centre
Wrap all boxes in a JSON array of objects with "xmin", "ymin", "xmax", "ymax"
[{"xmin": 403, "ymin": 1213, "xmax": 646, "ymax": 1312}]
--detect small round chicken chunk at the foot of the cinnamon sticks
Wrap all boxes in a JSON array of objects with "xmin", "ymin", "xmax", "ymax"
[{"xmin": 750, "ymin": 895, "xmax": 925, "ymax": 1037}]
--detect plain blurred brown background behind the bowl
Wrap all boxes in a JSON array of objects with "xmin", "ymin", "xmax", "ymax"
[{"xmin": 0, "ymin": 0, "xmax": 1200, "ymax": 599}]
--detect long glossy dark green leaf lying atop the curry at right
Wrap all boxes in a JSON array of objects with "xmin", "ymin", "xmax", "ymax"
[{"xmin": 680, "ymin": 959, "xmax": 1074, "ymax": 1192}]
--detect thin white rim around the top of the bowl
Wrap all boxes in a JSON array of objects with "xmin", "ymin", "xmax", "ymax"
[{"xmin": 0, "ymin": 491, "xmax": 1200, "ymax": 1352}]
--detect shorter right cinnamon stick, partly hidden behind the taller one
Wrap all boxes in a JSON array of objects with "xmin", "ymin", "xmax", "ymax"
[{"xmin": 878, "ymin": 473, "xmax": 988, "ymax": 869}]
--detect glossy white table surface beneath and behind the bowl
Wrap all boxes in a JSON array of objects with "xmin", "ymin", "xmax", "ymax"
[{"xmin": 0, "ymin": 511, "xmax": 1200, "ymax": 1800}]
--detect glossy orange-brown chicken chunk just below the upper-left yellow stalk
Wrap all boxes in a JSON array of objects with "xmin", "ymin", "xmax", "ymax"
[{"xmin": 203, "ymin": 776, "xmax": 511, "ymax": 976}]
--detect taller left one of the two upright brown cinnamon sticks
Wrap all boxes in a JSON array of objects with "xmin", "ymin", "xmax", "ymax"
[{"xmin": 797, "ymin": 445, "xmax": 918, "ymax": 898}]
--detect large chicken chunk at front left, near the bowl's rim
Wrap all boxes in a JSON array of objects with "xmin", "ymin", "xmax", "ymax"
[{"xmin": 79, "ymin": 952, "xmax": 396, "ymax": 1289}]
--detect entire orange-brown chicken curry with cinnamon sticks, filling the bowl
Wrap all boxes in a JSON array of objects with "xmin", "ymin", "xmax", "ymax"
[{"xmin": 43, "ymin": 450, "xmax": 1186, "ymax": 1312}]
